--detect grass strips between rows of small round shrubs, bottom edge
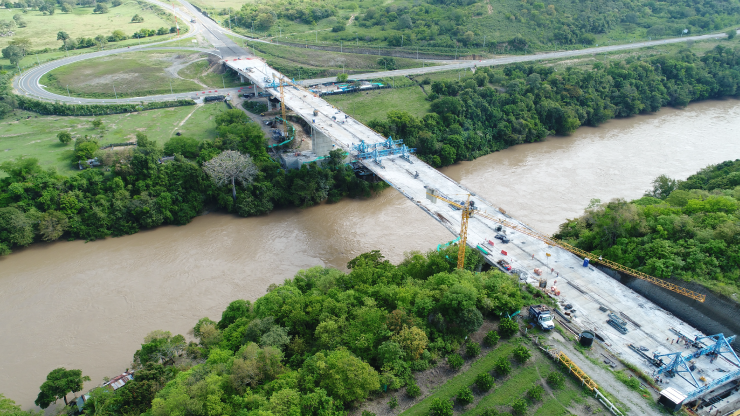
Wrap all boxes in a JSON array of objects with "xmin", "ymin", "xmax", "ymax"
[{"xmin": 401, "ymin": 339, "xmax": 596, "ymax": 416}]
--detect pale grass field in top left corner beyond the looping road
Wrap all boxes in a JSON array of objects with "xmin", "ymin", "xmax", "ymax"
[{"xmin": 0, "ymin": 1, "xmax": 174, "ymax": 50}]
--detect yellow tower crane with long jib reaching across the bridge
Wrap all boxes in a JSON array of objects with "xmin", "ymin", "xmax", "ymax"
[{"xmin": 427, "ymin": 189, "xmax": 706, "ymax": 302}]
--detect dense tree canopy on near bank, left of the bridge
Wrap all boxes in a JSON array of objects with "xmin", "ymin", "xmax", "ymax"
[{"xmin": 69, "ymin": 247, "xmax": 534, "ymax": 416}]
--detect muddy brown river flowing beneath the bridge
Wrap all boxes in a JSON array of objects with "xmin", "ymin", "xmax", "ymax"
[{"xmin": 0, "ymin": 100, "xmax": 740, "ymax": 407}]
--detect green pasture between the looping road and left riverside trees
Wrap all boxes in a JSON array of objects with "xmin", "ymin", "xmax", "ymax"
[{"xmin": 0, "ymin": 103, "xmax": 226, "ymax": 174}]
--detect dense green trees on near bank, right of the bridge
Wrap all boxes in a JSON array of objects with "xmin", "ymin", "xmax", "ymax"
[{"xmin": 556, "ymin": 160, "xmax": 740, "ymax": 291}]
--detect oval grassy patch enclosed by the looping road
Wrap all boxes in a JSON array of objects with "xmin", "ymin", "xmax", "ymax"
[{"xmin": 41, "ymin": 51, "xmax": 228, "ymax": 98}]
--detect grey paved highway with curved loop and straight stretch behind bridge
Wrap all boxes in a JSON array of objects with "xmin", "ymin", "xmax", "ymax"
[{"xmin": 13, "ymin": 0, "xmax": 740, "ymax": 104}]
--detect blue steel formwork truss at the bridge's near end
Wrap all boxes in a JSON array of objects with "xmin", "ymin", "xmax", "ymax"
[{"xmin": 653, "ymin": 334, "xmax": 740, "ymax": 403}]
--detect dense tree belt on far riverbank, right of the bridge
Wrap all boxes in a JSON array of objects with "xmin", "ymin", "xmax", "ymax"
[{"xmin": 369, "ymin": 46, "xmax": 740, "ymax": 166}]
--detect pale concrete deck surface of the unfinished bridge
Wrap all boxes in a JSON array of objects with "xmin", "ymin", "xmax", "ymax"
[{"xmin": 225, "ymin": 58, "xmax": 739, "ymax": 406}]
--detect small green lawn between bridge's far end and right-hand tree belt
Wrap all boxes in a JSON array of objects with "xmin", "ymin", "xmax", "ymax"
[{"xmin": 324, "ymin": 86, "xmax": 429, "ymax": 123}]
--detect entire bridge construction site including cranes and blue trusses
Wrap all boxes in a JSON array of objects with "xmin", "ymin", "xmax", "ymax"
[{"xmin": 225, "ymin": 58, "xmax": 740, "ymax": 415}]
